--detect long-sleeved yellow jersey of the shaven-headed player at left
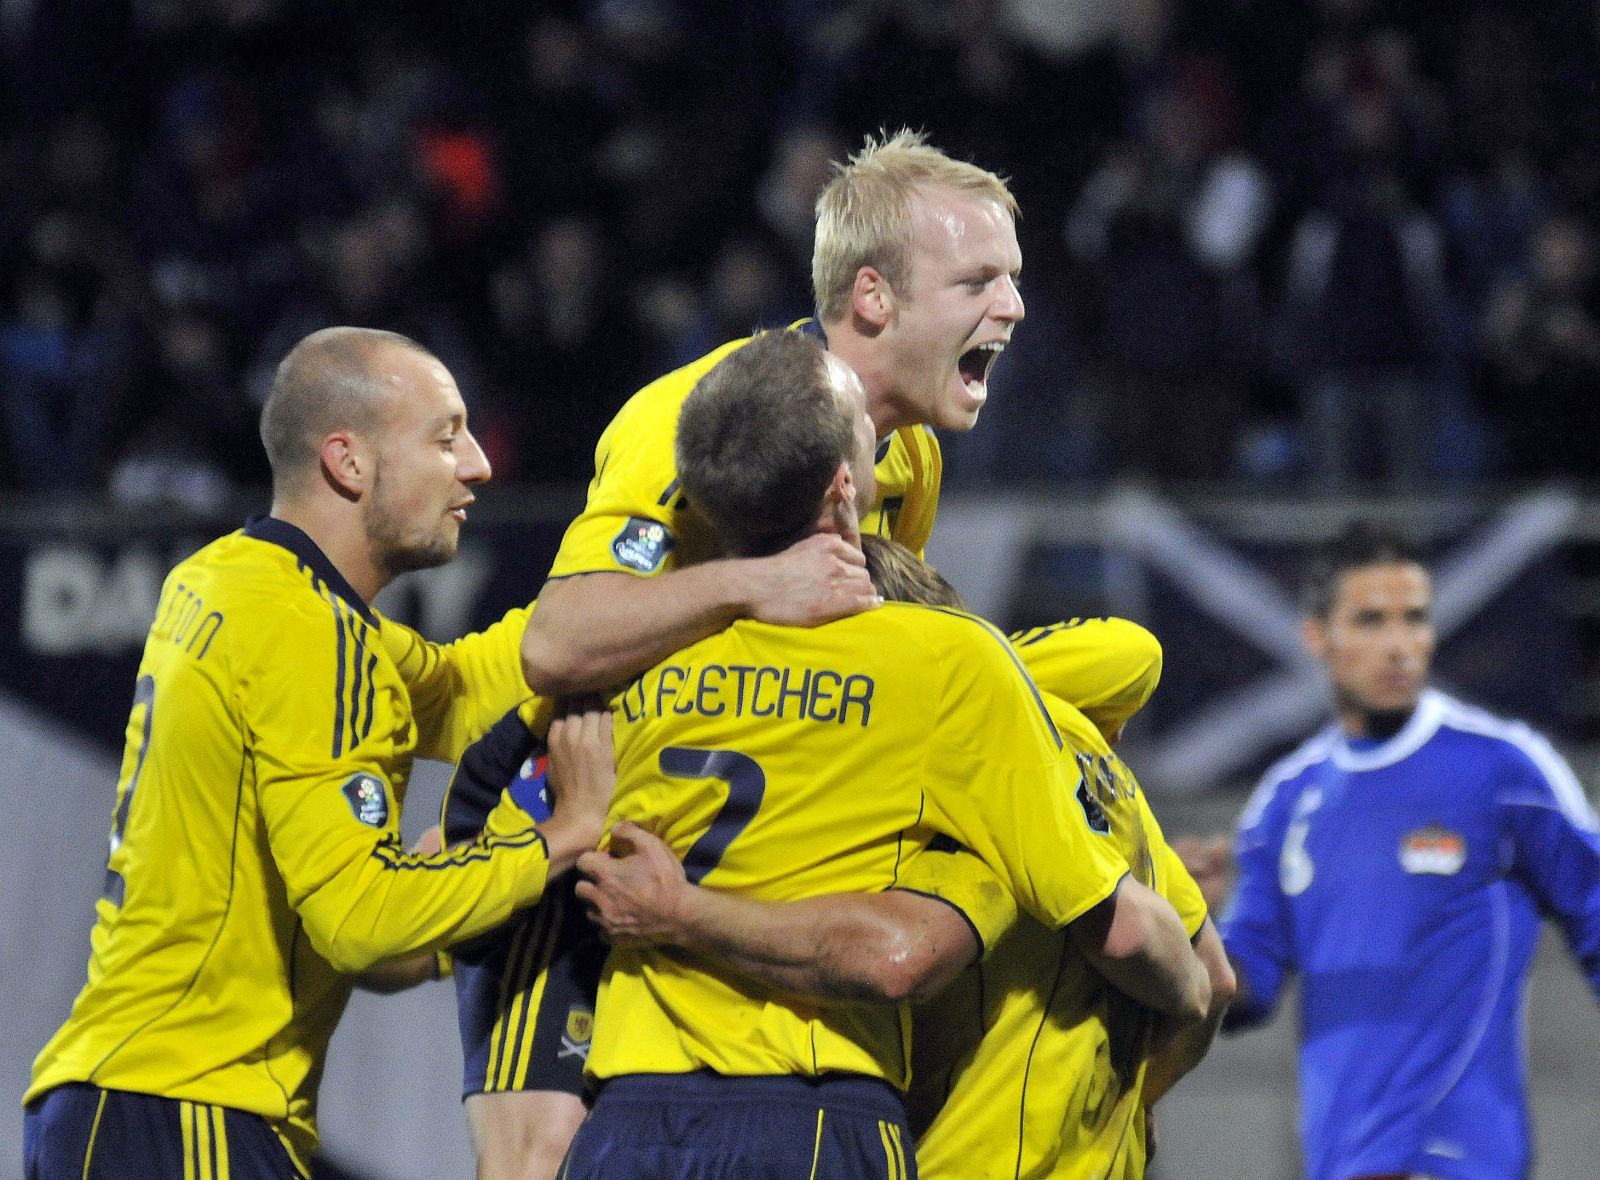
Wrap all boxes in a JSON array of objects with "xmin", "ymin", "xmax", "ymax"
[{"xmin": 26, "ymin": 518, "xmax": 547, "ymax": 1166}]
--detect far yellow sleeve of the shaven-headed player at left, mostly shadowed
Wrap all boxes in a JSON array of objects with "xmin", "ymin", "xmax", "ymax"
[{"xmin": 378, "ymin": 606, "xmax": 533, "ymax": 763}]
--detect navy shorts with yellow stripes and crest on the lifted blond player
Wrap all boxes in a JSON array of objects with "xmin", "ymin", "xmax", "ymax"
[{"xmin": 454, "ymin": 873, "xmax": 606, "ymax": 1097}]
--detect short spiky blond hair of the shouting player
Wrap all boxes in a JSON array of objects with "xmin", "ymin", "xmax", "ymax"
[{"xmin": 811, "ymin": 128, "xmax": 1019, "ymax": 323}]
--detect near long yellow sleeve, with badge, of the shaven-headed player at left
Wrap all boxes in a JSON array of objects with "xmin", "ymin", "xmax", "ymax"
[{"xmin": 238, "ymin": 627, "xmax": 549, "ymax": 972}]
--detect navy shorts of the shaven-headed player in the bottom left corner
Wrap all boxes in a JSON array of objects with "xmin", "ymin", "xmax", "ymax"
[{"xmin": 22, "ymin": 1082, "xmax": 307, "ymax": 1180}]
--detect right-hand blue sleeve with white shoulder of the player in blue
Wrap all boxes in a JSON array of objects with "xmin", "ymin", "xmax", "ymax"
[{"xmin": 1496, "ymin": 732, "xmax": 1600, "ymax": 996}]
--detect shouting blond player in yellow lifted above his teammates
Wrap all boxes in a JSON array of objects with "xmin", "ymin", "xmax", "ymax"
[{"xmin": 458, "ymin": 131, "xmax": 1024, "ymax": 1180}]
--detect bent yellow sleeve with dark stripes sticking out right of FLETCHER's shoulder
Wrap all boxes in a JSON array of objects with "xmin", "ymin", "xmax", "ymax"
[{"xmin": 1011, "ymin": 619, "xmax": 1162, "ymax": 739}]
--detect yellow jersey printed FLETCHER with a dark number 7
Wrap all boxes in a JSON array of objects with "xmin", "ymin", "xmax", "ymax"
[{"xmin": 589, "ymin": 603, "xmax": 1128, "ymax": 1086}]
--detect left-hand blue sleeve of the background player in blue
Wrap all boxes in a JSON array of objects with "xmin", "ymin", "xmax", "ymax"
[{"xmin": 1219, "ymin": 783, "xmax": 1293, "ymax": 1030}]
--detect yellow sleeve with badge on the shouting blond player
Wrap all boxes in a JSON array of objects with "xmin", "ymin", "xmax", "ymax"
[{"xmin": 549, "ymin": 341, "xmax": 746, "ymax": 577}]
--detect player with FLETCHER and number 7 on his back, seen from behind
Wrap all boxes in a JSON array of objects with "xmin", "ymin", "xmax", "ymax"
[{"xmin": 565, "ymin": 333, "xmax": 1210, "ymax": 1180}]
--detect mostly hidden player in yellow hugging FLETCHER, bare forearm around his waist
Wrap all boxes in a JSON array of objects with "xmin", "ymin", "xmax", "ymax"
[{"xmin": 579, "ymin": 534, "xmax": 1234, "ymax": 1180}]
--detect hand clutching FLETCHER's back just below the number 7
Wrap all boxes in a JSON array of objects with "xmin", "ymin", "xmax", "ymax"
[{"xmin": 576, "ymin": 820, "xmax": 694, "ymax": 945}]
